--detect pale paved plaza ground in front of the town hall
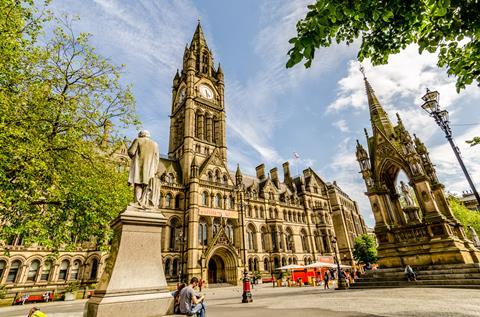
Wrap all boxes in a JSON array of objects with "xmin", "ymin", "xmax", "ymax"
[{"xmin": 0, "ymin": 285, "xmax": 480, "ymax": 317}]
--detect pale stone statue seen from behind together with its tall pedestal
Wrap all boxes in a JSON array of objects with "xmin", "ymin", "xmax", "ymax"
[{"xmin": 84, "ymin": 131, "xmax": 173, "ymax": 317}]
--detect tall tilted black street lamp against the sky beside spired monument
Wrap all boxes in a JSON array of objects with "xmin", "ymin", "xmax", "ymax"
[{"xmin": 422, "ymin": 88, "xmax": 480, "ymax": 207}]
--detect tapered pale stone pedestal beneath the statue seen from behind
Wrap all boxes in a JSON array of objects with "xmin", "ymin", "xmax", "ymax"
[{"xmin": 84, "ymin": 205, "xmax": 173, "ymax": 317}]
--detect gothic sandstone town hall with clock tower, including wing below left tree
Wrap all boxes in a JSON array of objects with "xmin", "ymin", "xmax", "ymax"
[{"xmin": 0, "ymin": 24, "xmax": 367, "ymax": 293}]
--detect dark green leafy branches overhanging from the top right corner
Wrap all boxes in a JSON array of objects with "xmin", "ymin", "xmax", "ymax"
[{"xmin": 287, "ymin": 0, "xmax": 480, "ymax": 91}]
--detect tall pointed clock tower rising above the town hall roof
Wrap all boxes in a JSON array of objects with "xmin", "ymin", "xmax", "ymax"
[{"xmin": 168, "ymin": 22, "xmax": 227, "ymax": 183}]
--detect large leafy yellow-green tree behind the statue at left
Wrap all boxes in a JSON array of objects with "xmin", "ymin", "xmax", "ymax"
[{"xmin": 0, "ymin": 0, "xmax": 137, "ymax": 248}]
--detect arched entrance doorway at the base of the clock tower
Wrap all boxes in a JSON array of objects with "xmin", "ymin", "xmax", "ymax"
[{"xmin": 207, "ymin": 246, "xmax": 239, "ymax": 285}]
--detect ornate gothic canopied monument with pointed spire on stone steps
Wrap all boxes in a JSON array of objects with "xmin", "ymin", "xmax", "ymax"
[{"xmin": 356, "ymin": 70, "xmax": 480, "ymax": 270}]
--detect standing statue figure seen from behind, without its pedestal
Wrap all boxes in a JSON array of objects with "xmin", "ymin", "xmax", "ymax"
[{"xmin": 128, "ymin": 130, "xmax": 159, "ymax": 208}]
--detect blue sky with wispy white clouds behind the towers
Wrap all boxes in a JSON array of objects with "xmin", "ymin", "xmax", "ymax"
[{"xmin": 48, "ymin": 0, "xmax": 480, "ymax": 226}]
